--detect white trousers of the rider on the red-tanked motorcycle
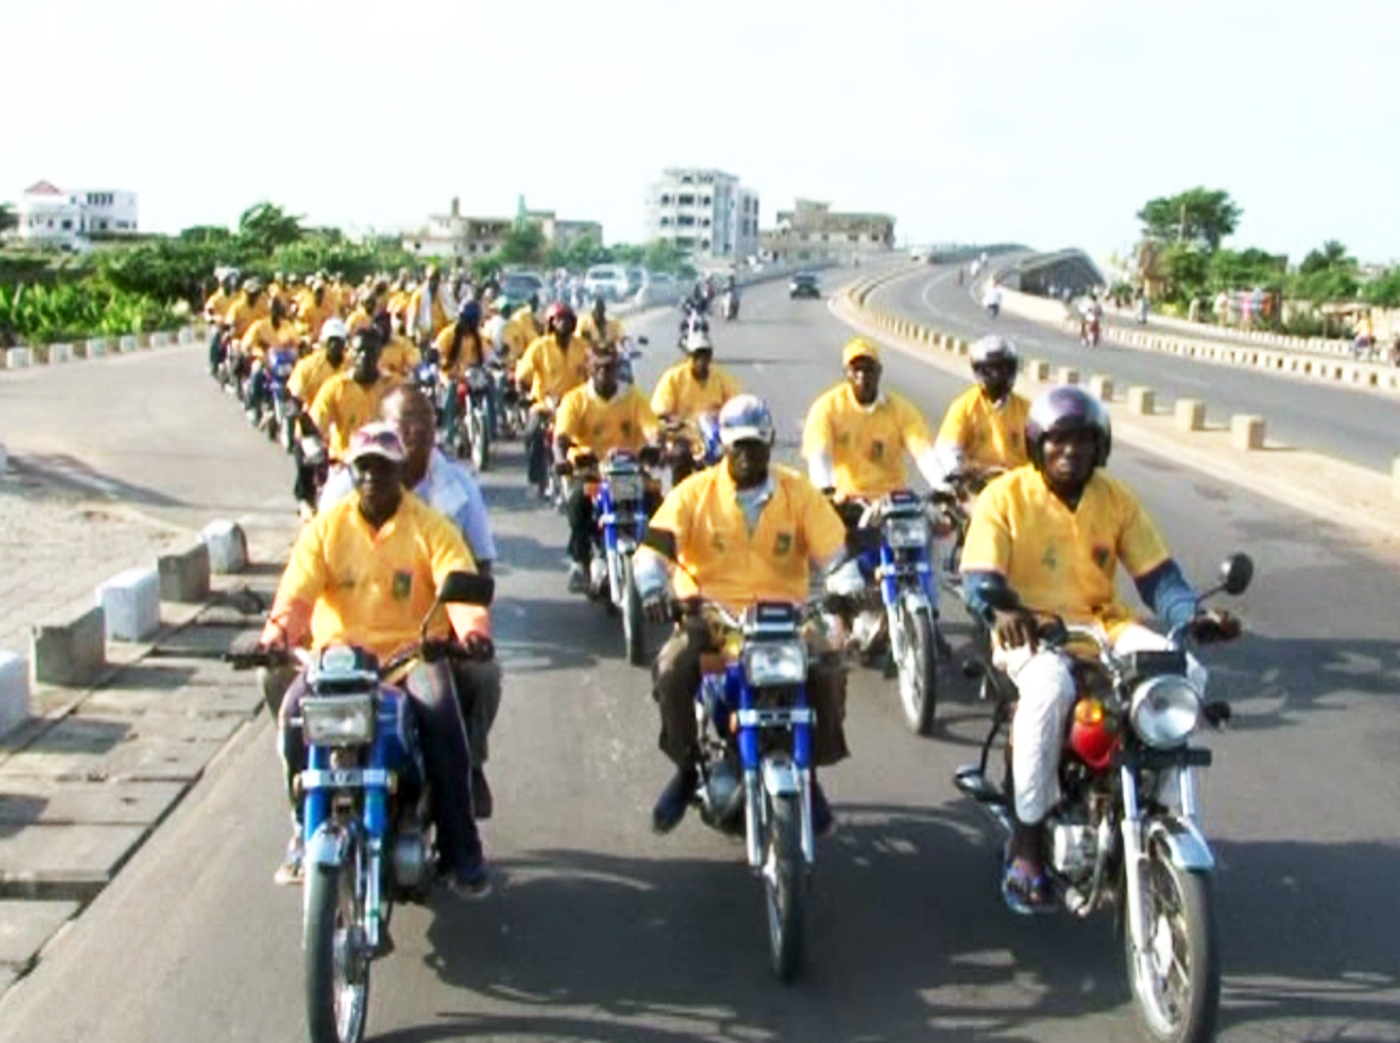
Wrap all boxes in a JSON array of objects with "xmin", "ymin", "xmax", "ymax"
[{"xmin": 991, "ymin": 623, "xmax": 1207, "ymax": 826}]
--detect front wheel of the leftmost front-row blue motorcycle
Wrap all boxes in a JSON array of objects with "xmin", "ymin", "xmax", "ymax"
[{"xmin": 302, "ymin": 858, "xmax": 370, "ymax": 1043}]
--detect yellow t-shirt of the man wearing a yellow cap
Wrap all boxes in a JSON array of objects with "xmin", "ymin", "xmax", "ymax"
[{"xmin": 802, "ymin": 384, "xmax": 934, "ymax": 498}]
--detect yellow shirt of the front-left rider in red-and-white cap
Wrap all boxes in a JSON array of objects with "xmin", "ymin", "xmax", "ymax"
[{"xmin": 270, "ymin": 491, "xmax": 484, "ymax": 659}]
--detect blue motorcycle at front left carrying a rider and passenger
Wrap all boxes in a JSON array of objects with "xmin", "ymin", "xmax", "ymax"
[{"xmin": 225, "ymin": 573, "xmax": 494, "ymax": 1043}]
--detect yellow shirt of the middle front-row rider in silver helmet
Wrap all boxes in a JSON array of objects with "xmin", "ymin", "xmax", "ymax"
[{"xmin": 638, "ymin": 465, "xmax": 846, "ymax": 612}]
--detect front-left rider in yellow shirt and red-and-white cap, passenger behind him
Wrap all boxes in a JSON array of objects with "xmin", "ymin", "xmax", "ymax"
[{"xmin": 260, "ymin": 423, "xmax": 493, "ymax": 896}]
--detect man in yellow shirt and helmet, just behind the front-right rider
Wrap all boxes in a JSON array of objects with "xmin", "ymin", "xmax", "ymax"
[{"xmin": 934, "ymin": 335, "xmax": 1030, "ymax": 477}]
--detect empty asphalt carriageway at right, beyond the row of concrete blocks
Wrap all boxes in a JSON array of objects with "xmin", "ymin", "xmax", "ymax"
[{"xmin": 871, "ymin": 259, "xmax": 1400, "ymax": 473}]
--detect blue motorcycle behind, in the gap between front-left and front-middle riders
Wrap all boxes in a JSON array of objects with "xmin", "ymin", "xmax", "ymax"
[{"xmin": 564, "ymin": 449, "xmax": 655, "ymax": 666}]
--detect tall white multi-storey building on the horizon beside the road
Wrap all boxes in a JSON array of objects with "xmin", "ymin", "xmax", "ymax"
[{"xmin": 647, "ymin": 168, "xmax": 759, "ymax": 258}]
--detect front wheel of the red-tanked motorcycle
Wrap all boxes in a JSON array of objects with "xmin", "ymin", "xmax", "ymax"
[{"xmin": 1123, "ymin": 844, "xmax": 1221, "ymax": 1043}]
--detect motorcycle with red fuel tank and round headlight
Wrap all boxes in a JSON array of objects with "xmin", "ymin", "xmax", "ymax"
[{"xmin": 955, "ymin": 554, "xmax": 1254, "ymax": 1043}]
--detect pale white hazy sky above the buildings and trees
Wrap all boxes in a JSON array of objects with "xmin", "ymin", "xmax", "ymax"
[{"xmin": 0, "ymin": 0, "xmax": 1400, "ymax": 262}]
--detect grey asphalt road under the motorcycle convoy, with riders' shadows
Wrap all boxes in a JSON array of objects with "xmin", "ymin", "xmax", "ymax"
[{"xmin": 0, "ymin": 274, "xmax": 1400, "ymax": 1043}]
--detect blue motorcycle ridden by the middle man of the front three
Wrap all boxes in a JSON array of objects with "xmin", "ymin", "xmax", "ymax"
[{"xmin": 648, "ymin": 582, "xmax": 819, "ymax": 983}]
